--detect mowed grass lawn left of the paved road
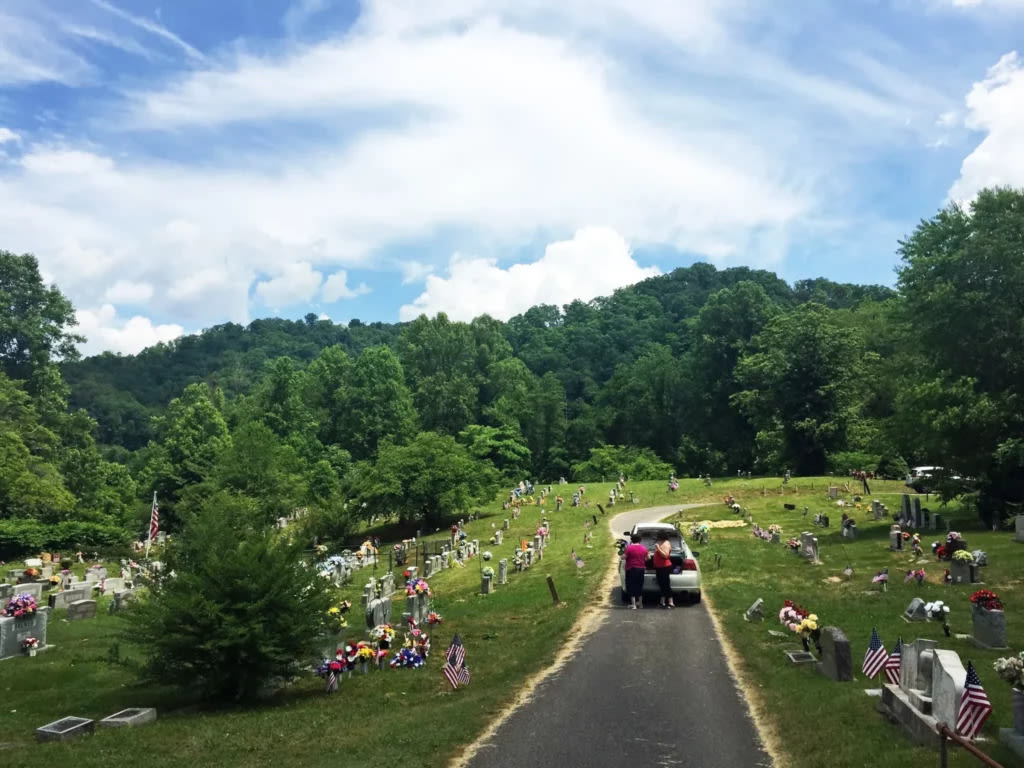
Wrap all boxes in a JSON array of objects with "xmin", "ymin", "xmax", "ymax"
[{"xmin": 0, "ymin": 495, "xmax": 613, "ymax": 768}]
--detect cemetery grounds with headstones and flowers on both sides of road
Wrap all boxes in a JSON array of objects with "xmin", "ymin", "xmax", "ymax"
[{"xmin": 0, "ymin": 478, "xmax": 1024, "ymax": 767}]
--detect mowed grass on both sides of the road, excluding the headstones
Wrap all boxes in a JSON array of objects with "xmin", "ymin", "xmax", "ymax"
[{"xmin": 0, "ymin": 478, "xmax": 1024, "ymax": 767}]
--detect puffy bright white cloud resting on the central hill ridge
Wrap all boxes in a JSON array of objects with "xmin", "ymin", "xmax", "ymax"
[{"xmin": 399, "ymin": 227, "xmax": 659, "ymax": 321}]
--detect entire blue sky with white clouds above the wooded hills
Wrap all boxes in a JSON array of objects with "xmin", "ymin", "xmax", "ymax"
[{"xmin": 0, "ymin": 0, "xmax": 1024, "ymax": 352}]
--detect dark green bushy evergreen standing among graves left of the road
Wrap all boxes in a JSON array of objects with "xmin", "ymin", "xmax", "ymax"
[{"xmin": 124, "ymin": 493, "xmax": 330, "ymax": 701}]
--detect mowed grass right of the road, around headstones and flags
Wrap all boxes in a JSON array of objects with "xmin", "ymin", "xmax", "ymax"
[{"xmin": 651, "ymin": 478, "xmax": 1024, "ymax": 768}]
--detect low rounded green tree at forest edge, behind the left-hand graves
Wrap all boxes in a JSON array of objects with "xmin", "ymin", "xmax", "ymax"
[{"xmin": 354, "ymin": 432, "xmax": 496, "ymax": 529}]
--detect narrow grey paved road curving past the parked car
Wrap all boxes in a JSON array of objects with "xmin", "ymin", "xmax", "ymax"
[{"xmin": 469, "ymin": 505, "xmax": 771, "ymax": 768}]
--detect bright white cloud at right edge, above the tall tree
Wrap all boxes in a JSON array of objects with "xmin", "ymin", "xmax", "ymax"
[{"xmin": 949, "ymin": 51, "xmax": 1024, "ymax": 203}]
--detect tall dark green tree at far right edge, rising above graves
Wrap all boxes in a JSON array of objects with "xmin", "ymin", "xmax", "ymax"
[{"xmin": 893, "ymin": 188, "xmax": 1024, "ymax": 522}]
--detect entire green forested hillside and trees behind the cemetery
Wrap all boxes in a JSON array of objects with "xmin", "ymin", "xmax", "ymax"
[{"xmin": 0, "ymin": 189, "xmax": 1024, "ymax": 545}]
